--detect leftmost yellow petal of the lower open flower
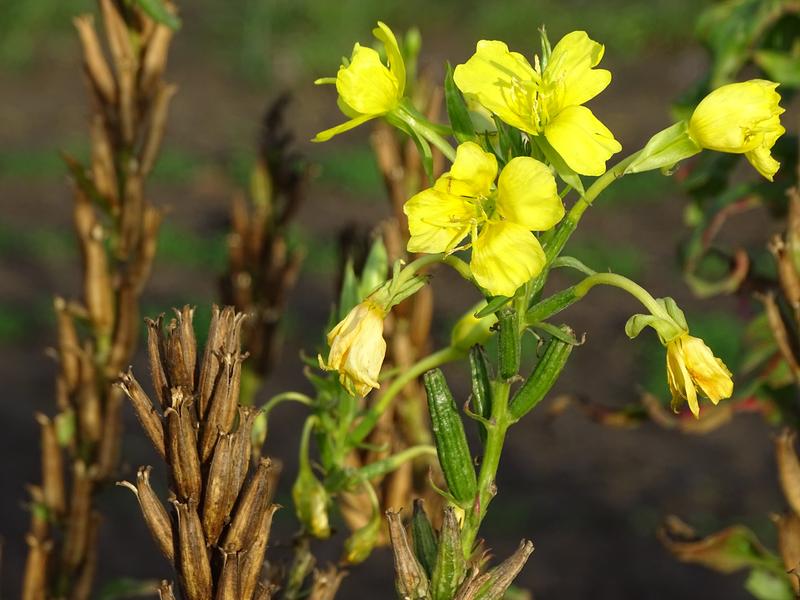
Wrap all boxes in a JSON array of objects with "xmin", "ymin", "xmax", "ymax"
[{"xmin": 403, "ymin": 188, "xmax": 473, "ymax": 254}]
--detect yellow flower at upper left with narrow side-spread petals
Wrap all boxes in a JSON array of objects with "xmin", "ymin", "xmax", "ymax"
[{"xmin": 313, "ymin": 21, "xmax": 406, "ymax": 142}]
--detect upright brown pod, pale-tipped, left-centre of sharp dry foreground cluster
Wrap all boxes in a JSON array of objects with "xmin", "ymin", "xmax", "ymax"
[{"xmin": 165, "ymin": 388, "xmax": 203, "ymax": 500}]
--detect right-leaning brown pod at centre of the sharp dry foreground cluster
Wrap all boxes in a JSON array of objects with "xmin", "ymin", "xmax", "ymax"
[{"xmin": 203, "ymin": 433, "xmax": 240, "ymax": 545}]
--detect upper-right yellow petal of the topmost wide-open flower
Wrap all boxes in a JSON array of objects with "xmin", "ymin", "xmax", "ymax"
[{"xmin": 542, "ymin": 31, "xmax": 611, "ymax": 108}]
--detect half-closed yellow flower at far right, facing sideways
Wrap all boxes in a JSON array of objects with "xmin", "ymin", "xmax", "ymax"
[{"xmin": 689, "ymin": 79, "xmax": 786, "ymax": 181}]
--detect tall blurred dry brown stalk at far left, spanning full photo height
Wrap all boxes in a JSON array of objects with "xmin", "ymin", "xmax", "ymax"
[{"xmin": 23, "ymin": 0, "xmax": 174, "ymax": 600}]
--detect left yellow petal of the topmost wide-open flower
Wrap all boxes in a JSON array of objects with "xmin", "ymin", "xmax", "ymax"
[{"xmin": 453, "ymin": 40, "xmax": 539, "ymax": 133}]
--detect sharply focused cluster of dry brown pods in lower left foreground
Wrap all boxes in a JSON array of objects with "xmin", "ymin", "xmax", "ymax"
[{"xmin": 119, "ymin": 306, "xmax": 278, "ymax": 600}]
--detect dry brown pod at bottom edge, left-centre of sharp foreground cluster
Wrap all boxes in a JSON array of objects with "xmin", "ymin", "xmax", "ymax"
[{"xmin": 172, "ymin": 500, "xmax": 213, "ymax": 600}]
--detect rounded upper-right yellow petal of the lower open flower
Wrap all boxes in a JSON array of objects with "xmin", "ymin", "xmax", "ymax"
[{"xmin": 496, "ymin": 156, "xmax": 564, "ymax": 231}]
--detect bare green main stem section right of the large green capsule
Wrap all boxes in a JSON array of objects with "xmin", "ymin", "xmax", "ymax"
[{"xmin": 461, "ymin": 381, "xmax": 511, "ymax": 559}]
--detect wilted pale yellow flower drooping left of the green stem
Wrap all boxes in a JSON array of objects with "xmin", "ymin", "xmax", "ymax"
[{"xmin": 320, "ymin": 299, "xmax": 386, "ymax": 396}]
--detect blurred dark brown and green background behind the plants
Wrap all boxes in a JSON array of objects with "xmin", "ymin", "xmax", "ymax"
[{"xmin": 0, "ymin": 0, "xmax": 783, "ymax": 599}]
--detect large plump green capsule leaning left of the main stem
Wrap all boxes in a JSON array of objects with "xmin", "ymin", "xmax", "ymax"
[{"xmin": 423, "ymin": 369, "xmax": 478, "ymax": 507}]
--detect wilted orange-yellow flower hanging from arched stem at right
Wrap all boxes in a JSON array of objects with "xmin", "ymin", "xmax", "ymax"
[{"xmin": 667, "ymin": 333, "xmax": 733, "ymax": 417}]
